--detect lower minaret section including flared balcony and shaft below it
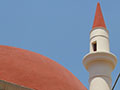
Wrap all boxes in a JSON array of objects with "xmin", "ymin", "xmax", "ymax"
[{"xmin": 83, "ymin": 52, "xmax": 117, "ymax": 90}]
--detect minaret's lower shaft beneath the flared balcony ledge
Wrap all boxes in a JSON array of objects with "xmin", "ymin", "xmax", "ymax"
[{"xmin": 88, "ymin": 60, "xmax": 112, "ymax": 90}]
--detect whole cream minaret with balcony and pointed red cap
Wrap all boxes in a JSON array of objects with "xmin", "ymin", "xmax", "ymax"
[{"xmin": 83, "ymin": 2, "xmax": 117, "ymax": 90}]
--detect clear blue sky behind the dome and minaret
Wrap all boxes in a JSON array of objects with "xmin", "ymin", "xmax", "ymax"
[{"xmin": 0, "ymin": 0, "xmax": 120, "ymax": 90}]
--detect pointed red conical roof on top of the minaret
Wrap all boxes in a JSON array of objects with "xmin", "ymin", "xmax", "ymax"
[{"xmin": 92, "ymin": 2, "xmax": 106, "ymax": 29}]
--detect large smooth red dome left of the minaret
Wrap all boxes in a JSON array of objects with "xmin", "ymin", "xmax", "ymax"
[{"xmin": 0, "ymin": 46, "xmax": 87, "ymax": 90}]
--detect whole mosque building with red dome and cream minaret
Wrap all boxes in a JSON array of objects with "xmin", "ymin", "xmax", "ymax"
[{"xmin": 0, "ymin": 2, "xmax": 117, "ymax": 90}]
